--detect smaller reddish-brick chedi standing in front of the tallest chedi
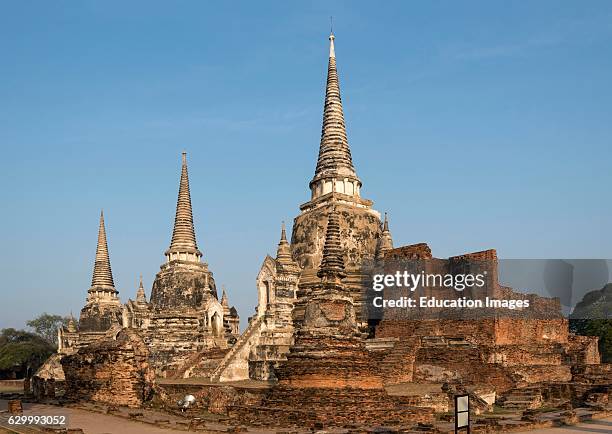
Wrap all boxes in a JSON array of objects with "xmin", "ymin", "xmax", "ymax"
[{"xmin": 235, "ymin": 208, "xmax": 433, "ymax": 427}]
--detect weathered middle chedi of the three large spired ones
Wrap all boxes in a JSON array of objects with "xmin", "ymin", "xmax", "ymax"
[{"xmin": 143, "ymin": 152, "xmax": 238, "ymax": 376}]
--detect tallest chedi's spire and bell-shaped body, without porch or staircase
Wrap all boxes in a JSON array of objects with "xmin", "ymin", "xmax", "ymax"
[{"xmin": 291, "ymin": 34, "xmax": 388, "ymax": 324}]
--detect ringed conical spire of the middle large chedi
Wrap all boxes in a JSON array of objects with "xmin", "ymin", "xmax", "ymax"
[{"xmin": 166, "ymin": 152, "xmax": 202, "ymax": 262}]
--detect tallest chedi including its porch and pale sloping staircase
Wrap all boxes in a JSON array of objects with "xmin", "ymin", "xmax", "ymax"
[{"xmin": 212, "ymin": 34, "xmax": 393, "ymax": 381}]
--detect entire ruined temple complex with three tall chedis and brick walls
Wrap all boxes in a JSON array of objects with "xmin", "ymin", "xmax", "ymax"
[{"xmin": 34, "ymin": 30, "xmax": 612, "ymax": 427}]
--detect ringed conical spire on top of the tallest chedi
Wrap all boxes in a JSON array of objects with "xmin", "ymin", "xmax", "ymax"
[{"xmin": 310, "ymin": 33, "xmax": 361, "ymax": 196}]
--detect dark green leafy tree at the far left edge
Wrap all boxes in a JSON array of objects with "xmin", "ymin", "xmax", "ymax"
[{"xmin": 0, "ymin": 328, "xmax": 55, "ymax": 373}]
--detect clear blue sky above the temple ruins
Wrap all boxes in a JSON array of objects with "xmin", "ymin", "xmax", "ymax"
[{"xmin": 0, "ymin": 1, "xmax": 612, "ymax": 328}]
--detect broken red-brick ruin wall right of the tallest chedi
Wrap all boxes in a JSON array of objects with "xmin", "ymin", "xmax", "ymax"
[{"xmin": 375, "ymin": 244, "xmax": 599, "ymax": 394}]
